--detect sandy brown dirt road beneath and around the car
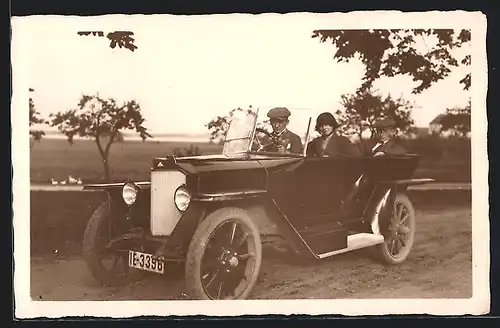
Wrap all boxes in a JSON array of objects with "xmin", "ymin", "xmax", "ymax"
[{"xmin": 31, "ymin": 207, "xmax": 472, "ymax": 301}]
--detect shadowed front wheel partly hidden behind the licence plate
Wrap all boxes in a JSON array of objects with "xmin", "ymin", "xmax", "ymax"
[{"xmin": 83, "ymin": 201, "xmax": 144, "ymax": 286}]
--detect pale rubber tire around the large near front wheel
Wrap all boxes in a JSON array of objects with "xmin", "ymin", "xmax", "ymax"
[{"xmin": 185, "ymin": 207, "xmax": 262, "ymax": 300}]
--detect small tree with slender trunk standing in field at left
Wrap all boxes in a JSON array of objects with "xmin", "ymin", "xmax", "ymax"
[{"xmin": 50, "ymin": 95, "xmax": 152, "ymax": 181}]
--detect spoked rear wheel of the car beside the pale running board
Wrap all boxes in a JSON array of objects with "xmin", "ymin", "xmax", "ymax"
[{"xmin": 375, "ymin": 194, "xmax": 416, "ymax": 264}]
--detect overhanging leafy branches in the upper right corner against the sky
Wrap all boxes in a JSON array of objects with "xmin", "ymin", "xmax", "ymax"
[{"xmin": 312, "ymin": 29, "xmax": 471, "ymax": 94}]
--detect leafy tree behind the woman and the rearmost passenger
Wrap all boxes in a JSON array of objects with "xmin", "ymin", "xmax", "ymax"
[{"xmin": 337, "ymin": 90, "xmax": 414, "ymax": 140}]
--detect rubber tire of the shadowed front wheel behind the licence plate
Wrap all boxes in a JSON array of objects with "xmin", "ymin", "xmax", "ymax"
[{"xmin": 83, "ymin": 201, "xmax": 144, "ymax": 286}]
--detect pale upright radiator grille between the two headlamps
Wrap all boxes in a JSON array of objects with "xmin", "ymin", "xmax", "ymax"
[{"xmin": 150, "ymin": 171, "xmax": 186, "ymax": 236}]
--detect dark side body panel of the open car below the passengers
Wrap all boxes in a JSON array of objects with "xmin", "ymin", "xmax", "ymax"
[{"xmin": 262, "ymin": 156, "xmax": 418, "ymax": 227}]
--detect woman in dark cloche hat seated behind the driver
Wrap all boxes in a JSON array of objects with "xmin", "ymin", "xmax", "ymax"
[{"xmin": 307, "ymin": 112, "xmax": 360, "ymax": 157}]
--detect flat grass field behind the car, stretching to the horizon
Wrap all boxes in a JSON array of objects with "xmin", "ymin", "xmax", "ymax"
[{"xmin": 30, "ymin": 139, "xmax": 471, "ymax": 183}]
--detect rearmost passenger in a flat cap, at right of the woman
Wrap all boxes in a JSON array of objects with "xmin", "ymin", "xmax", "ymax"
[{"xmin": 369, "ymin": 118, "xmax": 406, "ymax": 157}]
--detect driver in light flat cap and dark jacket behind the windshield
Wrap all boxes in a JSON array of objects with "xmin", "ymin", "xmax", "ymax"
[{"xmin": 262, "ymin": 107, "xmax": 302, "ymax": 154}]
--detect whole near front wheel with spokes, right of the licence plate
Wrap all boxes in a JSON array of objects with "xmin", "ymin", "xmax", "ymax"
[{"xmin": 185, "ymin": 208, "xmax": 262, "ymax": 300}]
